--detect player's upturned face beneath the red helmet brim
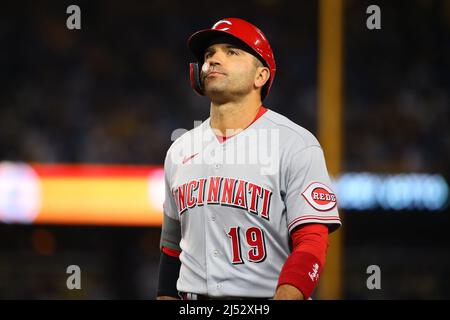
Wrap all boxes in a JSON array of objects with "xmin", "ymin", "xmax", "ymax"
[{"xmin": 202, "ymin": 43, "xmax": 258, "ymax": 97}]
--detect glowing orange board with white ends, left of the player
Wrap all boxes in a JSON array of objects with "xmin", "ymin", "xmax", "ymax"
[{"xmin": 0, "ymin": 162, "xmax": 164, "ymax": 226}]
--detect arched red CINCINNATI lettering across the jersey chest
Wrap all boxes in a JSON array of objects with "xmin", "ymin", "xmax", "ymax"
[{"xmin": 172, "ymin": 177, "xmax": 272, "ymax": 220}]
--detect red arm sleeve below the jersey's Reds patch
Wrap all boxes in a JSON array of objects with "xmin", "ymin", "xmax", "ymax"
[{"xmin": 278, "ymin": 223, "xmax": 328, "ymax": 299}]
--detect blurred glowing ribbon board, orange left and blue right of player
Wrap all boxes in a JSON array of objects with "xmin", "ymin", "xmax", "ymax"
[{"xmin": 0, "ymin": 162, "xmax": 449, "ymax": 226}]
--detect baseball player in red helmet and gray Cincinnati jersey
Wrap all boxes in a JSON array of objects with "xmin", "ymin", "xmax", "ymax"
[{"xmin": 157, "ymin": 18, "xmax": 341, "ymax": 300}]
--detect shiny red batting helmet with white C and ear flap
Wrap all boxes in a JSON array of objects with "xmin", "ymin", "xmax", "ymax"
[{"xmin": 188, "ymin": 18, "xmax": 277, "ymax": 100}]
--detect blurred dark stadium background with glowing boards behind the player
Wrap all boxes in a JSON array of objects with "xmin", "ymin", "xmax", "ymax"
[{"xmin": 0, "ymin": 0, "xmax": 450, "ymax": 299}]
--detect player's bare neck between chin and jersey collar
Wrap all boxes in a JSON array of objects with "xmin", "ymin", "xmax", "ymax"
[{"xmin": 210, "ymin": 97, "xmax": 262, "ymax": 137}]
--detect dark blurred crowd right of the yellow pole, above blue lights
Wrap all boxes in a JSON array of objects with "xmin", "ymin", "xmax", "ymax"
[{"xmin": 344, "ymin": 1, "xmax": 450, "ymax": 176}]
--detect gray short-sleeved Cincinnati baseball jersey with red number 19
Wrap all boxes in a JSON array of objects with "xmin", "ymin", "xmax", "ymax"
[{"xmin": 161, "ymin": 110, "xmax": 340, "ymax": 297}]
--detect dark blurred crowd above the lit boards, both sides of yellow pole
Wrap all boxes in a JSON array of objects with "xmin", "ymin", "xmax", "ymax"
[{"xmin": 0, "ymin": 0, "xmax": 450, "ymax": 173}]
